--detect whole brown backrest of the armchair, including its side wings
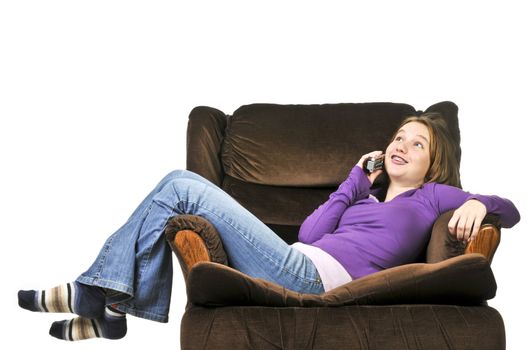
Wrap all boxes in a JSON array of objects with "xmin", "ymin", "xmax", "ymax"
[{"xmin": 187, "ymin": 101, "xmax": 461, "ymax": 243}]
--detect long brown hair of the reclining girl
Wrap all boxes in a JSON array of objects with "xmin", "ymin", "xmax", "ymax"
[{"xmin": 391, "ymin": 112, "xmax": 461, "ymax": 187}]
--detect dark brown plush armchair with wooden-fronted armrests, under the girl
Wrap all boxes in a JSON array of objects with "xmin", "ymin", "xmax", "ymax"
[{"xmin": 165, "ymin": 102, "xmax": 505, "ymax": 350}]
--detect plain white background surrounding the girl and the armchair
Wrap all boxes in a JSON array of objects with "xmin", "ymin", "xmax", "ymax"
[{"xmin": 0, "ymin": 0, "xmax": 527, "ymax": 350}]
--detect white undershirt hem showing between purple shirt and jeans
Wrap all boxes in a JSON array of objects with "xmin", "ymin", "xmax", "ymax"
[{"xmin": 291, "ymin": 242, "xmax": 352, "ymax": 292}]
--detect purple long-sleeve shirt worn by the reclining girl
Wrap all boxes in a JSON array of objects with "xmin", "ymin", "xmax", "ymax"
[{"xmin": 298, "ymin": 166, "xmax": 520, "ymax": 279}]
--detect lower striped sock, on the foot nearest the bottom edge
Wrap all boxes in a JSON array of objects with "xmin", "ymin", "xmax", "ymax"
[{"xmin": 49, "ymin": 306, "xmax": 126, "ymax": 341}]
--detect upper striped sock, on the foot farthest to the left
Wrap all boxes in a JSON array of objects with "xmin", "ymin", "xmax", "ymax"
[{"xmin": 18, "ymin": 282, "xmax": 106, "ymax": 318}]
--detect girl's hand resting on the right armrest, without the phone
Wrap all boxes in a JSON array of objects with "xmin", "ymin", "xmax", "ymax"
[{"xmin": 448, "ymin": 199, "xmax": 487, "ymax": 242}]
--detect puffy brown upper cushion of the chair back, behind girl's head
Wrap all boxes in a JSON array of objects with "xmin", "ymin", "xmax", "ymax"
[{"xmin": 221, "ymin": 103, "xmax": 415, "ymax": 187}]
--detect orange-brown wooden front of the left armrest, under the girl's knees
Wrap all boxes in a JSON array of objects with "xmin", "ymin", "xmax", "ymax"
[{"xmin": 173, "ymin": 230, "xmax": 211, "ymax": 272}]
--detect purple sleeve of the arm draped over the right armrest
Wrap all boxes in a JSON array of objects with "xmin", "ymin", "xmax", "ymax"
[{"xmin": 434, "ymin": 184, "xmax": 520, "ymax": 228}]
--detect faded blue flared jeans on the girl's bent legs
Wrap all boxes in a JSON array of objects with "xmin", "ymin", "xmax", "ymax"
[{"xmin": 77, "ymin": 170, "xmax": 324, "ymax": 322}]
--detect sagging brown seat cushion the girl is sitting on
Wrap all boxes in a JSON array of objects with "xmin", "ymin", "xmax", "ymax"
[{"xmin": 187, "ymin": 254, "xmax": 496, "ymax": 307}]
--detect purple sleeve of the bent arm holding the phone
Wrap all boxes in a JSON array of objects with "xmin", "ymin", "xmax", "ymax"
[{"xmin": 298, "ymin": 166, "xmax": 371, "ymax": 244}]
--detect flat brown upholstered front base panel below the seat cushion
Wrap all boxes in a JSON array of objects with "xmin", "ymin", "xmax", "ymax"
[{"xmin": 181, "ymin": 304, "xmax": 505, "ymax": 350}]
